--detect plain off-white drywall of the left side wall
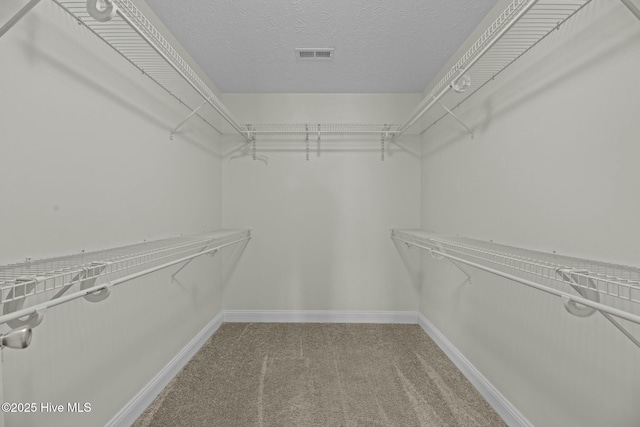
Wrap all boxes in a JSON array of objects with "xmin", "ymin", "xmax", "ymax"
[{"xmin": 0, "ymin": 2, "xmax": 222, "ymax": 426}]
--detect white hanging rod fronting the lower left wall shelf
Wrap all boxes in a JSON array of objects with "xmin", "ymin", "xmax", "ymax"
[{"xmin": 0, "ymin": 234, "xmax": 251, "ymax": 332}]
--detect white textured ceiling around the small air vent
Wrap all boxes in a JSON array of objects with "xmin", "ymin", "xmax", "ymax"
[{"xmin": 147, "ymin": 0, "xmax": 496, "ymax": 93}]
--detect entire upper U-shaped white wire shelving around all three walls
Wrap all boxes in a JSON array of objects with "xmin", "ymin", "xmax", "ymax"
[{"xmin": 4, "ymin": 0, "xmax": 640, "ymax": 143}]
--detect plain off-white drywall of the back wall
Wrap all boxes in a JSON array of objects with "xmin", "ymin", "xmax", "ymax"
[{"xmin": 223, "ymin": 94, "xmax": 420, "ymax": 311}]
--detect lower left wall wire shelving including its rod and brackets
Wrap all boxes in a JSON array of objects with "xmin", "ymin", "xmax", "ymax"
[{"xmin": 0, "ymin": 230, "xmax": 251, "ymax": 340}]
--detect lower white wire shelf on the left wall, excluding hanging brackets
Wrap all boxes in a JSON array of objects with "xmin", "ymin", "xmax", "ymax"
[{"xmin": 0, "ymin": 230, "xmax": 250, "ymax": 324}]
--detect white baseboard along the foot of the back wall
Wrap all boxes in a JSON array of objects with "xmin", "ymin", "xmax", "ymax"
[{"xmin": 224, "ymin": 310, "xmax": 418, "ymax": 324}]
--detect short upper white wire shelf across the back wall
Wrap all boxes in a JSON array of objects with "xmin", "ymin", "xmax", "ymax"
[{"xmin": 245, "ymin": 123, "xmax": 399, "ymax": 136}]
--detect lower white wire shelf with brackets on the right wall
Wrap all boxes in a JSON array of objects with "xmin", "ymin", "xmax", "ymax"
[{"xmin": 391, "ymin": 230, "xmax": 640, "ymax": 347}]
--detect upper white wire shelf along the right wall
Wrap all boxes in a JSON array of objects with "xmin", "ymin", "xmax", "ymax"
[{"xmin": 399, "ymin": 0, "xmax": 591, "ymax": 134}]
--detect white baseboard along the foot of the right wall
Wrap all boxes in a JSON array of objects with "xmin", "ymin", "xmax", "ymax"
[{"xmin": 418, "ymin": 313, "xmax": 533, "ymax": 427}]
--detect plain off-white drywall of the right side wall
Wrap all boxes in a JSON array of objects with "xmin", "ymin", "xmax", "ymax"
[{"xmin": 420, "ymin": 0, "xmax": 640, "ymax": 426}]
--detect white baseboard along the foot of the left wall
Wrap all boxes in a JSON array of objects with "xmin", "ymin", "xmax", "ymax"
[{"xmin": 106, "ymin": 313, "xmax": 224, "ymax": 427}]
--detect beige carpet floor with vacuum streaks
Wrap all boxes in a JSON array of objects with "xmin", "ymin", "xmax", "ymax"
[{"xmin": 134, "ymin": 323, "xmax": 504, "ymax": 427}]
